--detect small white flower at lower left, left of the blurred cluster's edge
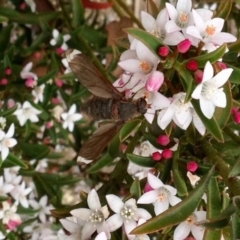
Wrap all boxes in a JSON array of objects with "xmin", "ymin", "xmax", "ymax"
[{"xmin": 10, "ymin": 182, "xmax": 32, "ymax": 208}]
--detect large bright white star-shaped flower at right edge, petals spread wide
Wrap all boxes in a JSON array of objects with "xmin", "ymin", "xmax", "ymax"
[{"xmin": 192, "ymin": 62, "xmax": 233, "ymax": 119}]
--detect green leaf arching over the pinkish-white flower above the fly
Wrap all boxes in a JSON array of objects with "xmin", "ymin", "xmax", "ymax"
[{"xmin": 124, "ymin": 28, "xmax": 162, "ymax": 57}]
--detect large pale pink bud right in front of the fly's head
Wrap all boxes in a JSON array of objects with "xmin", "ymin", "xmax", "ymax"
[{"xmin": 145, "ymin": 71, "xmax": 164, "ymax": 92}]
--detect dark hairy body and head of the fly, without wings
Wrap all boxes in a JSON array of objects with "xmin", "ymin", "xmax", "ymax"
[{"xmin": 82, "ymin": 98, "xmax": 147, "ymax": 121}]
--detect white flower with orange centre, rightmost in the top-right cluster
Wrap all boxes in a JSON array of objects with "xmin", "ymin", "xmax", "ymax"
[{"xmin": 186, "ymin": 9, "xmax": 237, "ymax": 51}]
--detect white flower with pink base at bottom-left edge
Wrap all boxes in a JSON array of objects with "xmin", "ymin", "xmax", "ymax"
[{"xmin": 0, "ymin": 201, "xmax": 21, "ymax": 227}]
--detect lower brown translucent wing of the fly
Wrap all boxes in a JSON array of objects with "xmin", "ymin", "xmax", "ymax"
[{"xmin": 79, "ymin": 121, "xmax": 124, "ymax": 160}]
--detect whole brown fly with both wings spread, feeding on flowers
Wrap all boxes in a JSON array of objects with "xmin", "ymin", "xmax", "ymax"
[{"xmin": 67, "ymin": 52, "xmax": 147, "ymax": 160}]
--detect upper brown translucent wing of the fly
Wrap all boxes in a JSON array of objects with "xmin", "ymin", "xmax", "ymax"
[{"xmin": 67, "ymin": 53, "xmax": 122, "ymax": 99}]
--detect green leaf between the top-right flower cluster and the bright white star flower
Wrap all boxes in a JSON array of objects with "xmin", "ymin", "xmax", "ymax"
[{"xmin": 182, "ymin": 44, "xmax": 226, "ymax": 68}]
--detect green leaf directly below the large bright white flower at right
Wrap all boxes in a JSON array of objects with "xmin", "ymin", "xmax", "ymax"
[{"xmin": 191, "ymin": 99, "xmax": 224, "ymax": 142}]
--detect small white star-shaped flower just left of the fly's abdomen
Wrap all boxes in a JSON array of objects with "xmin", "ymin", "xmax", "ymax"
[{"xmin": 61, "ymin": 104, "xmax": 82, "ymax": 132}]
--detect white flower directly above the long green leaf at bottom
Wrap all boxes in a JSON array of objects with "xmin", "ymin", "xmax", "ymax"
[{"xmin": 137, "ymin": 173, "xmax": 181, "ymax": 215}]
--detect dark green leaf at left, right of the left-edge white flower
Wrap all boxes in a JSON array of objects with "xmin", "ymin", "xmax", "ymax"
[{"xmin": 18, "ymin": 141, "xmax": 50, "ymax": 160}]
